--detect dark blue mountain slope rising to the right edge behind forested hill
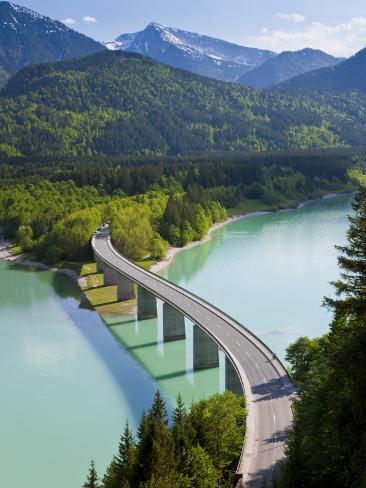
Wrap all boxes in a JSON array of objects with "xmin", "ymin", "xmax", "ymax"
[{"xmin": 280, "ymin": 48, "xmax": 366, "ymax": 92}]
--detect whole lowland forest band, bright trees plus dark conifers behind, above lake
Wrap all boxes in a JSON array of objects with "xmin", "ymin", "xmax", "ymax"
[{"xmin": 0, "ymin": 153, "xmax": 364, "ymax": 263}]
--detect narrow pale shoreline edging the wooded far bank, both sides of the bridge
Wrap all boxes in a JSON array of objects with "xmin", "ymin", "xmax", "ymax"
[{"xmin": 0, "ymin": 191, "xmax": 356, "ymax": 276}]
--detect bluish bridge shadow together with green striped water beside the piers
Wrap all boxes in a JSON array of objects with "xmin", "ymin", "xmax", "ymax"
[{"xmin": 52, "ymin": 273, "xmax": 225, "ymax": 412}]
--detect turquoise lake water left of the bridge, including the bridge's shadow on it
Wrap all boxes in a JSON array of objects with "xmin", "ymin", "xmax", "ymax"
[{"xmin": 0, "ymin": 268, "xmax": 223, "ymax": 488}]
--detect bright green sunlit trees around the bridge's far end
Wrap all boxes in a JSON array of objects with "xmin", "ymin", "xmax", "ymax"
[{"xmin": 0, "ymin": 179, "xmax": 226, "ymax": 263}]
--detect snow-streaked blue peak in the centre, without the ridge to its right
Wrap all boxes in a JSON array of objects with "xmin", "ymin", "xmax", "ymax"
[{"xmin": 106, "ymin": 22, "xmax": 275, "ymax": 81}]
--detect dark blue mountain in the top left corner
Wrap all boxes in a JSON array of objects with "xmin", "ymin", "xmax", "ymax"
[{"xmin": 0, "ymin": 2, "xmax": 105, "ymax": 85}]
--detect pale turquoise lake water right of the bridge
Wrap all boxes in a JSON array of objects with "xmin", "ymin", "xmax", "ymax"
[{"xmin": 162, "ymin": 195, "xmax": 353, "ymax": 358}]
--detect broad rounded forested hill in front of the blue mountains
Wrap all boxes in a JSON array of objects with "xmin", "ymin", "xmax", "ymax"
[{"xmin": 0, "ymin": 52, "xmax": 366, "ymax": 156}]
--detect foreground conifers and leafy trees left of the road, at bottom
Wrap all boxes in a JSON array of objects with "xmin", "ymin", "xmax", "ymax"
[{"xmin": 83, "ymin": 392, "xmax": 246, "ymax": 488}]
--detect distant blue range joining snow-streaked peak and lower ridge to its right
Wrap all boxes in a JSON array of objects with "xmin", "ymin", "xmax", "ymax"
[{"xmin": 106, "ymin": 22, "xmax": 342, "ymax": 88}]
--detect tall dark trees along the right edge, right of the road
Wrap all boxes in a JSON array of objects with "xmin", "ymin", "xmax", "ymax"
[{"xmin": 276, "ymin": 187, "xmax": 366, "ymax": 488}]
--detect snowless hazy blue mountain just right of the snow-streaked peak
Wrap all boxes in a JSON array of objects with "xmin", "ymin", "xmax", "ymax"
[{"xmin": 239, "ymin": 48, "xmax": 343, "ymax": 88}]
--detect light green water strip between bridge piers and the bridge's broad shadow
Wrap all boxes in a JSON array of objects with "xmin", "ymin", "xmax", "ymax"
[{"xmin": 103, "ymin": 300, "xmax": 224, "ymax": 404}]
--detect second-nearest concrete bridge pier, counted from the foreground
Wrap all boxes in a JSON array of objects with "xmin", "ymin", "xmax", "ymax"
[{"xmin": 193, "ymin": 325, "xmax": 219, "ymax": 369}]
